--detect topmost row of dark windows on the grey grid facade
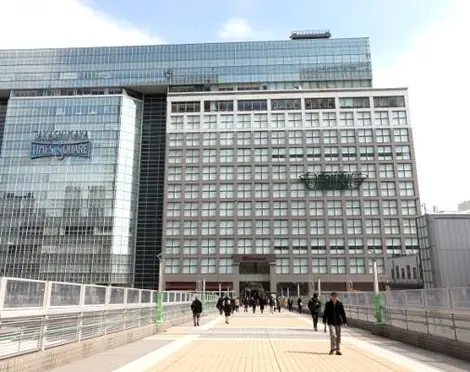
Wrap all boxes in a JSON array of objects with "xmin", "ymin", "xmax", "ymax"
[{"xmin": 171, "ymin": 96, "xmax": 405, "ymax": 113}]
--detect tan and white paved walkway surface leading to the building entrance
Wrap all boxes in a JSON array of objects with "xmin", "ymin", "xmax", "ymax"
[{"xmin": 49, "ymin": 312, "xmax": 470, "ymax": 372}]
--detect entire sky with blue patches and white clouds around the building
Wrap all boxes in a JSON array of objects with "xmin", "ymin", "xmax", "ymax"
[{"xmin": 0, "ymin": 0, "xmax": 470, "ymax": 209}]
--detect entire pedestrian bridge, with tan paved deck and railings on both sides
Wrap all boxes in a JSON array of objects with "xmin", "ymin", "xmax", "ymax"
[{"xmin": 0, "ymin": 278, "xmax": 470, "ymax": 372}]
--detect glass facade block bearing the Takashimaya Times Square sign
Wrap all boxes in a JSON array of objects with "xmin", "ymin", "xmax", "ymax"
[{"xmin": 0, "ymin": 92, "xmax": 142, "ymax": 284}]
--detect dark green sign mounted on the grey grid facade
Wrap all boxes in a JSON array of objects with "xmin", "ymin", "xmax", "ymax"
[{"xmin": 299, "ymin": 172, "xmax": 367, "ymax": 190}]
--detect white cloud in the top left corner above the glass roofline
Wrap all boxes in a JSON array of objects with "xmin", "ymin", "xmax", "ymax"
[{"xmin": 0, "ymin": 0, "xmax": 163, "ymax": 49}]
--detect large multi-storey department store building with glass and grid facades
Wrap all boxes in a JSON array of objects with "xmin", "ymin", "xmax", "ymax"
[{"xmin": 0, "ymin": 33, "xmax": 419, "ymax": 291}]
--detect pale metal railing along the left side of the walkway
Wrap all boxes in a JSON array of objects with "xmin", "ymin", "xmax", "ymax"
[{"xmin": 0, "ymin": 277, "xmax": 218, "ymax": 360}]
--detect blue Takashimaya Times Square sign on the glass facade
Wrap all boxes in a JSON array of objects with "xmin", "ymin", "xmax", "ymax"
[{"xmin": 29, "ymin": 130, "xmax": 91, "ymax": 160}]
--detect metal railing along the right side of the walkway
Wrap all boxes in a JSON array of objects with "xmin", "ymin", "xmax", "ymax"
[{"xmin": 294, "ymin": 287, "xmax": 470, "ymax": 343}]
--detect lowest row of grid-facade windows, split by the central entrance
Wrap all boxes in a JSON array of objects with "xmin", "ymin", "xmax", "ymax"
[{"xmin": 165, "ymin": 257, "xmax": 385, "ymax": 274}]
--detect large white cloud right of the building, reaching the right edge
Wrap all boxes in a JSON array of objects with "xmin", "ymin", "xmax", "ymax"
[{"xmin": 374, "ymin": 0, "xmax": 470, "ymax": 209}]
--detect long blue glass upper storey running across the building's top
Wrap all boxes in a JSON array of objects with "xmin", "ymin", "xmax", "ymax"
[{"xmin": 0, "ymin": 38, "xmax": 372, "ymax": 89}]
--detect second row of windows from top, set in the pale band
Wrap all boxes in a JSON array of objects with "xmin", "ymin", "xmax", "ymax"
[{"xmin": 169, "ymin": 111, "xmax": 408, "ymax": 131}]
